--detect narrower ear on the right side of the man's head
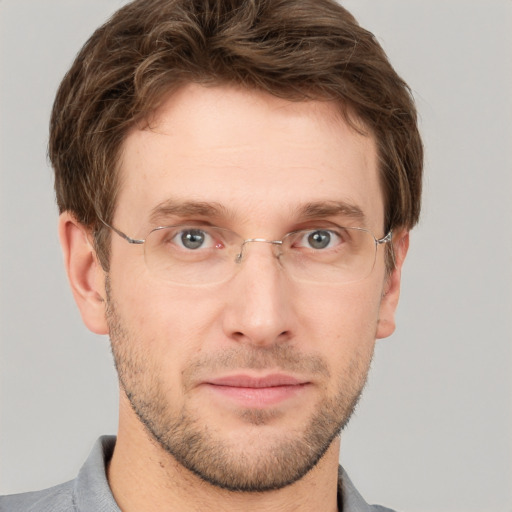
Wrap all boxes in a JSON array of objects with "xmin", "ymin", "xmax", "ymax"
[{"xmin": 376, "ymin": 231, "xmax": 409, "ymax": 338}]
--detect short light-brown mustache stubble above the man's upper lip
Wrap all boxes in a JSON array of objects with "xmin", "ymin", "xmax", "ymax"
[{"xmin": 182, "ymin": 344, "xmax": 330, "ymax": 383}]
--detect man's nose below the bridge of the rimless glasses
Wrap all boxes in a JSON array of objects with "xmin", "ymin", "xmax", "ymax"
[{"xmin": 223, "ymin": 239, "xmax": 296, "ymax": 347}]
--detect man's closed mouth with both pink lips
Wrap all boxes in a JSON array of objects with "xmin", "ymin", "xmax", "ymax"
[{"xmin": 203, "ymin": 374, "xmax": 311, "ymax": 409}]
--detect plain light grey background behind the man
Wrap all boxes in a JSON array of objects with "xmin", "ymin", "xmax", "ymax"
[{"xmin": 0, "ymin": 0, "xmax": 512, "ymax": 512}]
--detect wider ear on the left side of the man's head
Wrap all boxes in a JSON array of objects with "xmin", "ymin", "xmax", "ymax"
[{"xmin": 59, "ymin": 212, "xmax": 108, "ymax": 334}]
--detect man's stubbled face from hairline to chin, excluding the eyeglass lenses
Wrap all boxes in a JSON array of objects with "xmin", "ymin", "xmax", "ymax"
[{"xmin": 97, "ymin": 85, "xmax": 400, "ymax": 491}]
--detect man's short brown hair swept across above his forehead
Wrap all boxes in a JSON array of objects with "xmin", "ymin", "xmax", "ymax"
[{"xmin": 49, "ymin": 0, "xmax": 423, "ymax": 270}]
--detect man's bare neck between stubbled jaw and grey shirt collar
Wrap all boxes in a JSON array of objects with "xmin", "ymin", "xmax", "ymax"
[{"xmin": 108, "ymin": 402, "xmax": 339, "ymax": 512}]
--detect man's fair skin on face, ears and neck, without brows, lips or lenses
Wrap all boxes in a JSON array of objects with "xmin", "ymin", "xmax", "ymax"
[{"xmin": 59, "ymin": 85, "xmax": 408, "ymax": 512}]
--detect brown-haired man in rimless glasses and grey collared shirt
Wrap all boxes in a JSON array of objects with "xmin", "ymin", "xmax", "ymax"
[{"xmin": 0, "ymin": 0, "xmax": 422, "ymax": 512}]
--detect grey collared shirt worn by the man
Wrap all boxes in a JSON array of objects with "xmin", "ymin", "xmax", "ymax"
[{"xmin": 0, "ymin": 436, "xmax": 393, "ymax": 512}]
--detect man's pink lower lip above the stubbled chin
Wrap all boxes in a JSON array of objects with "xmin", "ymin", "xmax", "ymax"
[{"xmin": 207, "ymin": 384, "xmax": 307, "ymax": 408}]
